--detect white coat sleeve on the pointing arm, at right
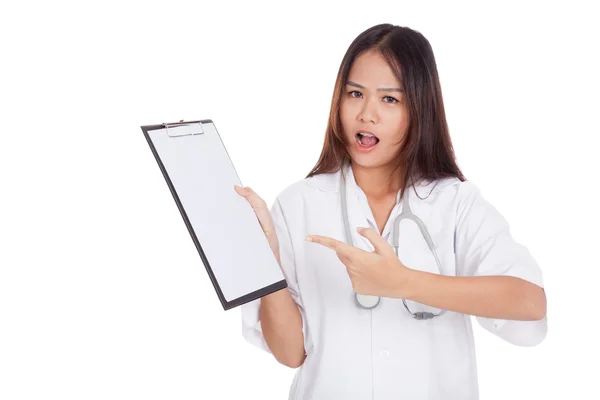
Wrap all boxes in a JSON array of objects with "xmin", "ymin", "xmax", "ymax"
[{"xmin": 454, "ymin": 181, "xmax": 548, "ymax": 346}]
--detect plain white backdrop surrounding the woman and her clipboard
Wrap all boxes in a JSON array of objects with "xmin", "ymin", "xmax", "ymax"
[{"xmin": 0, "ymin": 1, "xmax": 600, "ymax": 400}]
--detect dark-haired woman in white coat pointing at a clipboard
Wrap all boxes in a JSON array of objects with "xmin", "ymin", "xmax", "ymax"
[{"xmin": 236, "ymin": 24, "xmax": 547, "ymax": 400}]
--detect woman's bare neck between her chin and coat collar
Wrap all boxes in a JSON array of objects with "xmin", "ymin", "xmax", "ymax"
[{"xmin": 351, "ymin": 161, "xmax": 402, "ymax": 200}]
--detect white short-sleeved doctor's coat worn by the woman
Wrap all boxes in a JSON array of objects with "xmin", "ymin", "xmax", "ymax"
[{"xmin": 241, "ymin": 164, "xmax": 547, "ymax": 400}]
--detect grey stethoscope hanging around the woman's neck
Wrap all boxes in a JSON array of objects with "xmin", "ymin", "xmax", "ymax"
[{"xmin": 340, "ymin": 158, "xmax": 446, "ymax": 320}]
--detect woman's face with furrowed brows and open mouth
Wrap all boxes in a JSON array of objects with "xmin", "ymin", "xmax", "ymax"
[{"xmin": 340, "ymin": 50, "xmax": 408, "ymax": 167}]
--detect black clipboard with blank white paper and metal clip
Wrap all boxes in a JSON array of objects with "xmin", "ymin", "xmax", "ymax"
[{"xmin": 141, "ymin": 119, "xmax": 287, "ymax": 310}]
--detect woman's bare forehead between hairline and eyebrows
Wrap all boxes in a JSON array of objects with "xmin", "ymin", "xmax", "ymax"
[{"xmin": 348, "ymin": 50, "xmax": 400, "ymax": 88}]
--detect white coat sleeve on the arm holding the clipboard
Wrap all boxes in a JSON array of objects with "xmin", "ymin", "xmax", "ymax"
[{"xmin": 241, "ymin": 198, "xmax": 309, "ymax": 354}]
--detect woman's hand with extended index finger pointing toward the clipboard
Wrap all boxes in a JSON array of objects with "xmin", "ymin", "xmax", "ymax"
[{"xmin": 306, "ymin": 228, "xmax": 412, "ymax": 298}]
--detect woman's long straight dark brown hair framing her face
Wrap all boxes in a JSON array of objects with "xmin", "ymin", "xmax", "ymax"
[{"xmin": 306, "ymin": 24, "xmax": 466, "ymax": 200}]
